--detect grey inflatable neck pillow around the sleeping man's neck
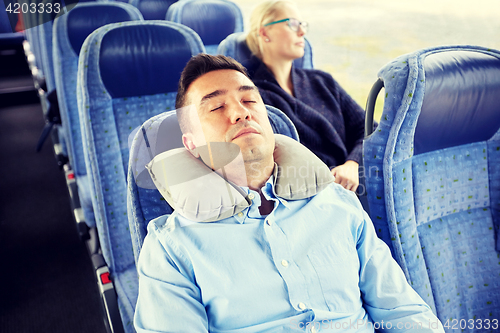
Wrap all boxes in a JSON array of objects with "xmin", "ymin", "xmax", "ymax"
[{"xmin": 146, "ymin": 134, "xmax": 334, "ymax": 222}]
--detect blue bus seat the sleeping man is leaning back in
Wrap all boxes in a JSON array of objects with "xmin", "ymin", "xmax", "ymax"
[{"xmin": 127, "ymin": 105, "xmax": 299, "ymax": 263}]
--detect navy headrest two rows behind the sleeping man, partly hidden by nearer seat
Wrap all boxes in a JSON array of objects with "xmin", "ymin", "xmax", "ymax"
[{"xmin": 66, "ymin": 3, "xmax": 141, "ymax": 55}]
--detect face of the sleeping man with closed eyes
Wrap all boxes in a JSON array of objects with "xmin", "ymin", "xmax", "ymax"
[{"xmin": 187, "ymin": 69, "xmax": 274, "ymax": 163}]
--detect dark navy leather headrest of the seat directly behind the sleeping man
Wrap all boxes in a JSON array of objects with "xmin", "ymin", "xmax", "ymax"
[{"xmin": 99, "ymin": 21, "xmax": 199, "ymax": 98}]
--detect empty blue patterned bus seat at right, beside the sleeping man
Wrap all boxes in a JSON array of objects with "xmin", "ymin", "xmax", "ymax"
[{"xmin": 364, "ymin": 46, "xmax": 500, "ymax": 326}]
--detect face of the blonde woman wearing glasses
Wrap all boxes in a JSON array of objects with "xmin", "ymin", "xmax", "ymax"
[{"xmin": 260, "ymin": 5, "xmax": 305, "ymax": 61}]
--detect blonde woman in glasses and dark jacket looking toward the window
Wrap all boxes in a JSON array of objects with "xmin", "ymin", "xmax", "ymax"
[{"xmin": 246, "ymin": 0, "xmax": 364, "ymax": 191}]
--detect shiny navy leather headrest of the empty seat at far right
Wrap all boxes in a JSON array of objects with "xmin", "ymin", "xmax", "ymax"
[{"xmin": 415, "ymin": 50, "xmax": 500, "ymax": 155}]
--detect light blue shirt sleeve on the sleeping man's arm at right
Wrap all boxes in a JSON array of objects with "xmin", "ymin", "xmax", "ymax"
[{"xmin": 357, "ymin": 212, "xmax": 444, "ymax": 333}]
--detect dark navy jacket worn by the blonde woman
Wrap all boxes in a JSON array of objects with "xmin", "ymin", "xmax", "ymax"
[{"xmin": 252, "ymin": 63, "xmax": 365, "ymax": 168}]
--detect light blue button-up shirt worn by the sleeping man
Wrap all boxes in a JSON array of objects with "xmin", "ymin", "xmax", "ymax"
[{"xmin": 134, "ymin": 177, "xmax": 444, "ymax": 333}]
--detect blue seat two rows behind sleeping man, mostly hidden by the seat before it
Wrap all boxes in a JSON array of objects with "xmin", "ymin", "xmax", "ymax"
[{"xmin": 53, "ymin": 2, "xmax": 142, "ymax": 227}]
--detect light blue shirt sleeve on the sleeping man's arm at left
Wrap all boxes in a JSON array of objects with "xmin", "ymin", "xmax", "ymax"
[{"xmin": 134, "ymin": 218, "xmax": 208, "ymax": 333}]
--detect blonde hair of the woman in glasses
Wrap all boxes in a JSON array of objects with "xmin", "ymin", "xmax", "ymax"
[{"xmin": 246, "ymin": 0, "xmax": 296, "ymax": 60}]
